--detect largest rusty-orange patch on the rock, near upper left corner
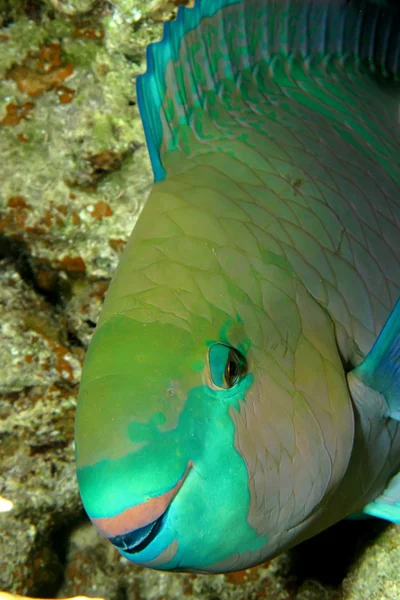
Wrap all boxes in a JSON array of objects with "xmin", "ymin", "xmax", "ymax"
[{"xmin": 6, "ymin": 43, "xmax": 74, "ymax": 99}]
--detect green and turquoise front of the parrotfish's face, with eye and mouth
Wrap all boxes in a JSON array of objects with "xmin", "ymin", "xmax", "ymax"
[{"xmin": 75, "ymin": 304, "xmax": 268, "ymax": 571}]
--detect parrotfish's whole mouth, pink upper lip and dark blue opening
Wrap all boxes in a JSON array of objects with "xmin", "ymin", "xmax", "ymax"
[{"xmin": 91, "ymin": 461, "xmax": 193, "ymax": 554}]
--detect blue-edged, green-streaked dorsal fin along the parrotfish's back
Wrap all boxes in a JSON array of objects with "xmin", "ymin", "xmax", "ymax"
[{"xmin": 137, "ymin": 0, "xmax": 400, "ymax": 181}]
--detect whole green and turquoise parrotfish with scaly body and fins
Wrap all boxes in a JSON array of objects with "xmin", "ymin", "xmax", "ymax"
[{"xmin": 75, "ymin": 0, "xmax": 400, "ymax": 573}]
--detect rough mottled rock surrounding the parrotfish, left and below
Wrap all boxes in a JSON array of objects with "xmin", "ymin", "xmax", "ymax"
[{"xmin": 0, "ymin": 0, "xmax": 400, "ymax": 600}]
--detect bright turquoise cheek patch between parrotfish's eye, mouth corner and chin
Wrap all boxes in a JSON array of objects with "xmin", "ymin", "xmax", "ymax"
[{"xmin": 172, "ymin": 382, "xmax": 264, "ymax": 571}]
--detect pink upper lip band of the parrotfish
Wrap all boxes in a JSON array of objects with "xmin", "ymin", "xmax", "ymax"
[{"xmin": 91, "ymin": 462, "xmax": 193, "ymax": 538}]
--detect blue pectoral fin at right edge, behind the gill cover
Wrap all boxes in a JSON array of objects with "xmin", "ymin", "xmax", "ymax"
[{"xmin": 350, "ymin": 300, "xmax": 400, "ymax": 422}]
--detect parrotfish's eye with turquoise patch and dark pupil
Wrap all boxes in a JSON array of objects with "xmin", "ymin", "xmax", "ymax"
[{"xmin": 208, "ymin": 344, "xmax": 246, "ymax": 390}]
